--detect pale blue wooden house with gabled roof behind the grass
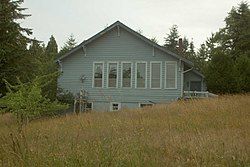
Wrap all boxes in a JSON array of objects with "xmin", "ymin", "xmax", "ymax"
[{"xmin": 58, "ymin": 21, "xmax": 205, "ymax": 111}]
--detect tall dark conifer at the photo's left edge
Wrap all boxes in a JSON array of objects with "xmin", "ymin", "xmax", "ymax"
[{"xmin": 0, "ymin": 0, "xmax": 32, "ymax": 94}]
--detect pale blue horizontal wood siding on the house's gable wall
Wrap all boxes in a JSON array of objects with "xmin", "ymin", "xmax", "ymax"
[{"xmin": 58, "ymin": 28, "xmax": 181, "ymax": 103}]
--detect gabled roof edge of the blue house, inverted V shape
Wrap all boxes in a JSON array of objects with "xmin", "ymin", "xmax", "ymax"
[{"xmin": 58, "ymin": 21, "xmax": 193, "ymax": 66}]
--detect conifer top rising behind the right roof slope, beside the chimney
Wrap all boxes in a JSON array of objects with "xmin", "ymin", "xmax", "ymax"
[{"xmin": 164, "ymin": 25, "xmax": 180, "ymax": 51}]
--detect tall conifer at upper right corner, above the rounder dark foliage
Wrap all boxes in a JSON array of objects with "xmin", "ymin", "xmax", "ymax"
[{"xmin": 221, "ymin": 2, "xmax": 250, "ymax": 60}]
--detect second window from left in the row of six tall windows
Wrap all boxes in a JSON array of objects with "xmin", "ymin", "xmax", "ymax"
[{"xmin": 108, "ymin": 63, "xmax": 118, "ymax": 88}]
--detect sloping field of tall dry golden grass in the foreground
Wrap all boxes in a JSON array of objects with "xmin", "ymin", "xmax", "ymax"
[{"xmin": 0, "ymin": 95, "xmax": 250, "ymax": 166}]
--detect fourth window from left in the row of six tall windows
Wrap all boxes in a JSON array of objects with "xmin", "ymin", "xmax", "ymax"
[{"xmin": 136, "ymin": 62, "xmax": 147, "ymax": 88}]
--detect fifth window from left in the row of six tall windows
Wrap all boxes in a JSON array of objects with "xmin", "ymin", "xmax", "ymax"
[{"xmin": 150, "ymin": 62, "xmax": 161, "ymax": 89}]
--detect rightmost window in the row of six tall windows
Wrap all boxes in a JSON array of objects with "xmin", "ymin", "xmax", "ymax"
[{"xmin": 165, "ymin": 61, "xmax": 177, "ymax": 89}]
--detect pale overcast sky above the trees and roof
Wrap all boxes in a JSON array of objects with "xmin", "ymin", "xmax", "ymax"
[{"xmin": 22, "ymin": 0, "xmax": 244, "ymax": 48}]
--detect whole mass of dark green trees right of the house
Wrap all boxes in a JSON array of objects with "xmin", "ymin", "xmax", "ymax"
[{"xmin": 204, "ymin": 2, "xmax": 250, "ymax": 93}]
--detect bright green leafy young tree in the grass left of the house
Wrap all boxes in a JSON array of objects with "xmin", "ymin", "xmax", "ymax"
[{"xmin": 0, "ymin": 76, "xmax": 67, "ymax": 129}]
